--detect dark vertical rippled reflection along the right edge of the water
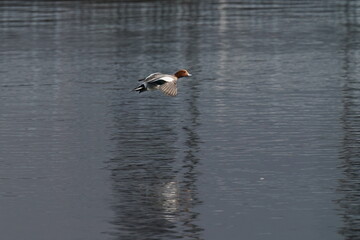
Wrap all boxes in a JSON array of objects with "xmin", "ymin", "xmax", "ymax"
[{"xmin": 338, "ymin": 1, "xmax": 360, "ymax": 240}]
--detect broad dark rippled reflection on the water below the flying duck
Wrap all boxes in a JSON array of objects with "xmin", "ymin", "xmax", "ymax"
[{"xmin": 109, "ymin": 87, "xmax": 202, "ymax": 239}]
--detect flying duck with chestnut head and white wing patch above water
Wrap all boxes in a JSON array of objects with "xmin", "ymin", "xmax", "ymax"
[{"xmin": 133, "ymin": 69, "xmax": 191, "ymax": 97}]
